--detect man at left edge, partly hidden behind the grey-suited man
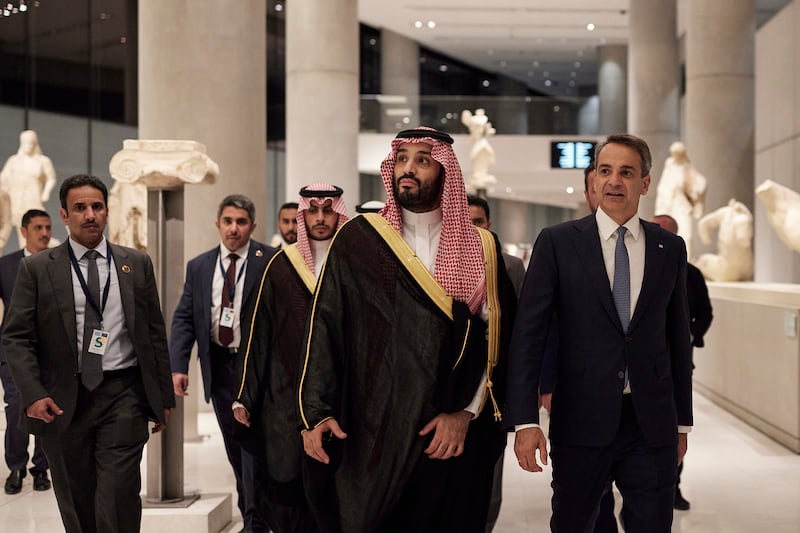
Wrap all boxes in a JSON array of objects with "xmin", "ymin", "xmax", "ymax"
[{"xmin": 0, "ymin": 209, "xmax": 53, "ymax": 494}]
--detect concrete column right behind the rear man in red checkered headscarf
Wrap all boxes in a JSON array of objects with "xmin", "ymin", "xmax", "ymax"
[{"xmin": 286, "ymin": 0, "xmax": 359, "ymax": 212}]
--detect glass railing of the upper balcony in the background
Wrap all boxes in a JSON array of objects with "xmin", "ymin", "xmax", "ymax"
[{"xmin": 360, "ymin": 94, "xmax": 598, "ymax": 135}]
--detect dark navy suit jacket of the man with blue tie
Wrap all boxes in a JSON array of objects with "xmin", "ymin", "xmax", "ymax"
[{"xmin": 506, "ymin": 215, "xmax": 692, "ymax": 446}]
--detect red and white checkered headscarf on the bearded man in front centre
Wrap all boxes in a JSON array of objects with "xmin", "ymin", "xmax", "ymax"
[{"xmin": 380, "ymin": 126, "xmax": 486, "ymax": 314}]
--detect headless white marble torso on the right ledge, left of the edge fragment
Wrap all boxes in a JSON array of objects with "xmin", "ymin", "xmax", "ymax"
[{"xmin": 694, "ymin": 199, "xmax": 753, "ymax": 281}]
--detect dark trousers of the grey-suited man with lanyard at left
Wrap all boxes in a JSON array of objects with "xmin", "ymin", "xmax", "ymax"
[{"xmin": 42, "ymin": 367, "xmax": 149, "ymax": 533}]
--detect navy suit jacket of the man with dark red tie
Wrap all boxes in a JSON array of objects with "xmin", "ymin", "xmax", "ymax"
[{"xmin": 169, "ymin": 239, "xmax": 276, "ymax": 402}]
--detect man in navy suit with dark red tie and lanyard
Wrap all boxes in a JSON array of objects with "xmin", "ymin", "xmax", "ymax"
[{"xmin": 169, "ymin": 194, "xmax": 276, "ymax": 531}]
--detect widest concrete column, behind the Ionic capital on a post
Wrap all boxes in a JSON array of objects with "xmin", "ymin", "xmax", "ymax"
[{"xmin": 138, "ymin": 0, "xmax": 267, "ymax": 492}]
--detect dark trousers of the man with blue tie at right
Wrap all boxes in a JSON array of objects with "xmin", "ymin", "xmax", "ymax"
[{"xmin": 550, "ymin": 397, "xmax": 678, "ymax": 533}]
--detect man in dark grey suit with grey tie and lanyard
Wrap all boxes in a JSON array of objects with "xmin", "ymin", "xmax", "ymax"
[{"xmin": 3, "ymin": 175, "xmax": 175, "ymax": 533}]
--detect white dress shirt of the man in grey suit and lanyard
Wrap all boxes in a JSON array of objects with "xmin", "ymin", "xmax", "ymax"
[{"xmin": 69, "ymin": 237, "xmax": 137, "ymax": 371}]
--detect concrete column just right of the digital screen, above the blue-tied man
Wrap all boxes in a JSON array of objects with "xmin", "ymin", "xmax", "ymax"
[{"xmin": 628, "ymin": 0, "xmax": 680, "ymax": 218}]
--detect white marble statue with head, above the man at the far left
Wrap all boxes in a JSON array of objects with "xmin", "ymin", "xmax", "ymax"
[{"xmin": 0, "ymin": 130, "xmax": 56, "ymax": 248}]
